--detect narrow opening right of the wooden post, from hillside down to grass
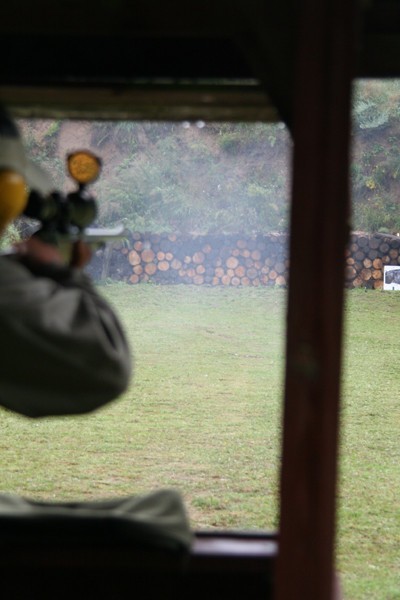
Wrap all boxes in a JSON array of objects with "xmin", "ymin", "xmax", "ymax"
[{"xmin": 338, "ymin": 79, "xmax": 400, "ymax": 599}]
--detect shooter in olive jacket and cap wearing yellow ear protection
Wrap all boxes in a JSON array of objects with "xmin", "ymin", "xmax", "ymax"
[{"xmin": 0, "ymin": 111, "xmax": 132, "ymax": 417}]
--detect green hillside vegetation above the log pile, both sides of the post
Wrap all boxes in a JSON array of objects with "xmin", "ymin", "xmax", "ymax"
[{"xmin": 16, "ymin": 80, "xmax": 400, "ymax": 233}]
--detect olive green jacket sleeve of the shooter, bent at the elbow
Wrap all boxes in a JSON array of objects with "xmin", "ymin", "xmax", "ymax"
[{"xmin": 0, "ymin": 258, "xmax": 132, "ymax": 417}]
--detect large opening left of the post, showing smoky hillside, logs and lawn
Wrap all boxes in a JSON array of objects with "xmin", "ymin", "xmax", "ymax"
[{"xmin": 1, "ymin": 119, "xmax": 291, "ymax": 529}]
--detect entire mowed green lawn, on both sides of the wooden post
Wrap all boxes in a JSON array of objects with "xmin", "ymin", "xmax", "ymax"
[{"xmin": 0, "ymin": 284, "xmax": 400, "ymax": 600}]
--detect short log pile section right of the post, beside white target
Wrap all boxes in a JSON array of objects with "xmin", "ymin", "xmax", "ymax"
[{"xmin": 345, "ymin": 232, "xmax": 400, "ymax": 289}]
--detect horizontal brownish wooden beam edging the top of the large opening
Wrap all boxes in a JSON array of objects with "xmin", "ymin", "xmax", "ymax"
[{"xmin": 0, "ymin": 82, "xmax": 279, "ymax": 122}]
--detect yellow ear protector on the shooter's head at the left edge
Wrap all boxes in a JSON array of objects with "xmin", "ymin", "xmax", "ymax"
[{"xmin": 0, "ymin": 169, "xmax": 28, "ymax": 230}]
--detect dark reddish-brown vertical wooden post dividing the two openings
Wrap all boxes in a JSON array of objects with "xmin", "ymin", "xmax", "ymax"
[{"xmin": 276, "ymin": 0, "xmax": 354, "ymax": 600}]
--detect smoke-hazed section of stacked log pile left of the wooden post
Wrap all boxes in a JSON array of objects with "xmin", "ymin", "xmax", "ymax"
[{"xmin": 92, "ymin": 233, "xmax": 289, "ymax": 286}]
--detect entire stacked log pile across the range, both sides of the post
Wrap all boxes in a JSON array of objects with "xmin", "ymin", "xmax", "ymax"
[{"xmin": 89, "ymin": 232, "xmax": 400, "ymax": 289}]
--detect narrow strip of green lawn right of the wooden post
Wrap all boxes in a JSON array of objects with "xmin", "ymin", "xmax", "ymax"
[{"xmin": 338, "ymin": 290, "xmax": 400, "ymax": 600}]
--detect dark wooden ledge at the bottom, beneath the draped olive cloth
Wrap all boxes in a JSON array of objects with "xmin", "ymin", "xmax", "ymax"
[{"xmin": 0, "ymin": 523, "xmax": 277, "ymax": 600}]
